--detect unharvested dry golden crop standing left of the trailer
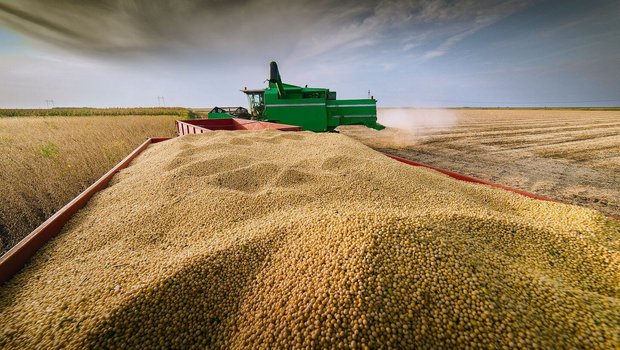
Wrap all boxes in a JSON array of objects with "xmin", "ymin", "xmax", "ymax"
[{"xmin": 0, "ymin": 115, "xmax": 179, "ymax": 253}]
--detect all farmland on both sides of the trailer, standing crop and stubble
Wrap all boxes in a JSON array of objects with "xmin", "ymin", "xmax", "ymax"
[{"xmin": 0, "ymin": 108, "xmax": 620, "ymax": 252}]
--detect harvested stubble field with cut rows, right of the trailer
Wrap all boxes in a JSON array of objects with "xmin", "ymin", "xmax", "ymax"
[{"xmin": 343, "ymin": 109, "xmax": 620, "ymax": 216}]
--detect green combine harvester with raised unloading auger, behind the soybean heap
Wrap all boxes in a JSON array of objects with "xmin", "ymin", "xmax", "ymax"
[{"xmin": 208, "ymin": 62, "xmax": 384, "ymax": 132}]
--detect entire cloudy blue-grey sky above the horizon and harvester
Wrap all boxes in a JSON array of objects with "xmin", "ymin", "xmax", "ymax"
[{"xmin": 0, "ymin": 0, "xmax": 620, "ymax": 108}]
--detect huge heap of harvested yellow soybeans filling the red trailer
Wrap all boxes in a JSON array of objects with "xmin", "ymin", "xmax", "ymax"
[{"xmin": 0, "ymin": 131, "xmax": 620, "ymax": 349}]
